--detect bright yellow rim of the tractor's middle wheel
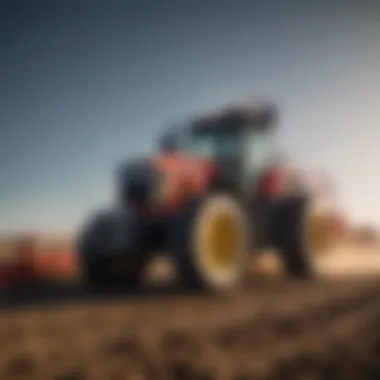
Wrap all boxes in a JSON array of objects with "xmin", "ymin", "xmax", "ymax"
[{"xmin": 201, "ymin": 211, "xmax": 241, "ymax": 273}]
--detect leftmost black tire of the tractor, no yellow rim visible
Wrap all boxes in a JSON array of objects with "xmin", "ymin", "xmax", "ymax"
[{"xmin": 78, "ymin": 208, "xmax": 146, "ymax": 291}]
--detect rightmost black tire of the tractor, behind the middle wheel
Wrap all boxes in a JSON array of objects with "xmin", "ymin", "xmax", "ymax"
[{"xmin": 274, "ymin": 197, "xmax": 315, "ymax": 279}]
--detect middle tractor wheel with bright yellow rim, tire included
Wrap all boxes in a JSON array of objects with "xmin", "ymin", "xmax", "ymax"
[{"xmin": 171, "ymin": 193, "xmax": 249, "ymax": 292}]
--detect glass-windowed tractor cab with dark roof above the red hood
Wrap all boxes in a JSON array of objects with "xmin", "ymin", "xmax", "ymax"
[{"xmin": 159, "ymin": 106, "xmax": 276, "ymax": 193}]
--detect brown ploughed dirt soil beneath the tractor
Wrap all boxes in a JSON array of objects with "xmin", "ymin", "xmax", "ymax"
[{"xmin": 0, "ymin": 277, "xmax": 380, "ymax": 380}]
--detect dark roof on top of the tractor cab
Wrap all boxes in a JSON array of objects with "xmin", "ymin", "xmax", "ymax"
[{"xmin": 190, "ymin": 104, "xmax": 277, "ymax": 131}]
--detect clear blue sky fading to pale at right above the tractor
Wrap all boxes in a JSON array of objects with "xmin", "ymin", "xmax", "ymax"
[{"xmin": 0, "ymin": 0, "xmax": 380, "ymax": 235}]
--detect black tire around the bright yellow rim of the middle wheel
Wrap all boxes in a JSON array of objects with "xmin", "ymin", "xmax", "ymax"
[{"xmin": 169, "ymin": 193, "xmax": 249, "ymax": 293}]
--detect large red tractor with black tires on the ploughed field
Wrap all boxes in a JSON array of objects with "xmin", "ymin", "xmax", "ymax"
[{"xmin": 77, "ymin": 104, "xmax": 328, "ymax": 293}]
